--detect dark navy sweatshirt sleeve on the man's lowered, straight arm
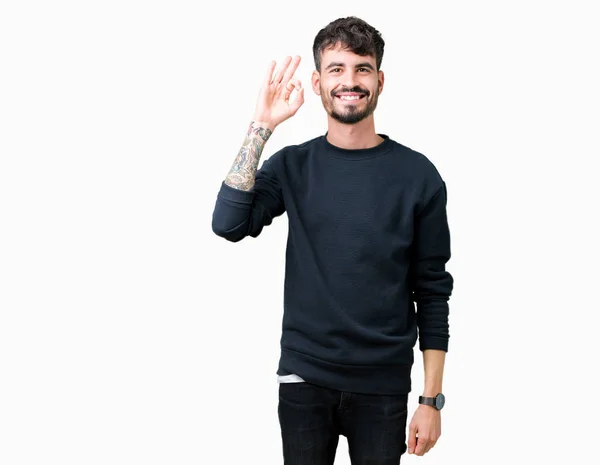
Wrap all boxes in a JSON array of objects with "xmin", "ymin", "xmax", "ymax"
[{"xmin": 412, "ymin": 181, "xmax": 454, "ymax": 351}]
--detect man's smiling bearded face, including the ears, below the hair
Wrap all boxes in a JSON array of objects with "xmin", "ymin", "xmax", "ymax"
[{"xmin": 312, "ymin": 45, "xmax": 383, "ymax": 124}]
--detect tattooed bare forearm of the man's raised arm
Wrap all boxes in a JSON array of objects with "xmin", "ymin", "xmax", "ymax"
[{"xmin": 225, "ymin": 121, "xmax": 273, "ymax": 191}]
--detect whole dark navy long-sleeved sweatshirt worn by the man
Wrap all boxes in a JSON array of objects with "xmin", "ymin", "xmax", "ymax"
[{"xmin": 212, "ymin": 134, "xmax": 453, "ymax": 394}]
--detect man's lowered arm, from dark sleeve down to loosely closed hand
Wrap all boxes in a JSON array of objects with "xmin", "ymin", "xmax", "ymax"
[{"xmin": 408, "ymin": 181, "xmax": 454, "ymax": 455}]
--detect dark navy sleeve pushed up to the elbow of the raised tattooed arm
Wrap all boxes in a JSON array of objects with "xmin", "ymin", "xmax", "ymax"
[{"xmin": 212, "ymin": 156, "xmax": 285, "ymax": 242}]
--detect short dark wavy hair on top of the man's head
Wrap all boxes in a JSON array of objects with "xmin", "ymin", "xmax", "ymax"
[{"xmin": 313, "ymin": 16, "xmax": 385, "ymax": 71}]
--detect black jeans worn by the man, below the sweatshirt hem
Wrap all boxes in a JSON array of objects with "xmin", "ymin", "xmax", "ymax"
[{"xmin": 278, "ymin": 383, "xmax": 408, "ymax": 465}]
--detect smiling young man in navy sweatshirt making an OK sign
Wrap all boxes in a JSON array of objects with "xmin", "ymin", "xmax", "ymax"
[{"xmin": 212, "ymin": 17, "xmax": 453, "ymax": 465}]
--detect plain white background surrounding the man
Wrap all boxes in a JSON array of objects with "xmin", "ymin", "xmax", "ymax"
[{"xmin": 0, "ymin": 0, "xmax": 600, "ymax": 465}]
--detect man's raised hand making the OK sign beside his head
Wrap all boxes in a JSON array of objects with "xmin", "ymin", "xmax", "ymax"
[{"xmin": 253, "ymin": 56, "xmax": 304, "ymax": 131}]
